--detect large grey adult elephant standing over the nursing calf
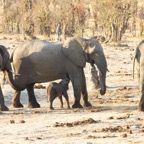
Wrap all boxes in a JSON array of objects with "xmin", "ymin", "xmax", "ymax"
[{"xmin": 7, "ymin": 38, "xmax": 107, "ymax": 108}]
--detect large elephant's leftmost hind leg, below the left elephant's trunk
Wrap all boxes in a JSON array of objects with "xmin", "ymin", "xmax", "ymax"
[{"xmin": 12, "ymin": 91, "xmax": 23, "ymax": 108}]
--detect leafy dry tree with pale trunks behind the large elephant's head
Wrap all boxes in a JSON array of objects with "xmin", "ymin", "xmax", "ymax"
[{"xmin": 93, "ymin": 0, "xmax": 131, "ymax": 42}]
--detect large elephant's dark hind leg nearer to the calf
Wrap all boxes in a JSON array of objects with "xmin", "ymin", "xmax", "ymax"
[{"xmin": 27, "ymin": 84, "xmax": 40, "ymax": 108}]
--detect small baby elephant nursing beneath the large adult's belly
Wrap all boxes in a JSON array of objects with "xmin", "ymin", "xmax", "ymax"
[{"xmin": 47, "ymin": 78, "xmax": 70, "ymax": 110}]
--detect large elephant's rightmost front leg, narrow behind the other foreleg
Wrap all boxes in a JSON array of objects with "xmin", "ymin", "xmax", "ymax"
[{"xmin": 82, "ymin": 71, "xmax": 92, "ymax": 107}]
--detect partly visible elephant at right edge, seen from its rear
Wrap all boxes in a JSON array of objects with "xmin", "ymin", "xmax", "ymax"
[{"xmin": 133, "ymin": 40, "xmax": 144, "ymax": 111}]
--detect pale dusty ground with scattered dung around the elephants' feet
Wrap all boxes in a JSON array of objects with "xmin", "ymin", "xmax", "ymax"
[{"xmin": 0, "ymin": 36, "xmax": 144, "ymax": 144}]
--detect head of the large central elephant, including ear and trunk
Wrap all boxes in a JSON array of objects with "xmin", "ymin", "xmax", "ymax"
[{"xmin": 63, "ymin": 38, "xmax": 107, "ymax": 95}]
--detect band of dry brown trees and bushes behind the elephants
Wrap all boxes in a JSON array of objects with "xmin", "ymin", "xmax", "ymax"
[{"xmin": 0, "ymin": 0, "xmax": 144, "ymax": 42}]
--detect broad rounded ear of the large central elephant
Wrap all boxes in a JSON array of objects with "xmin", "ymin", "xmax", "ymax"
[{"xmin": 62, "ymin": 38, "xmax": 86, "ymax": 67}]
